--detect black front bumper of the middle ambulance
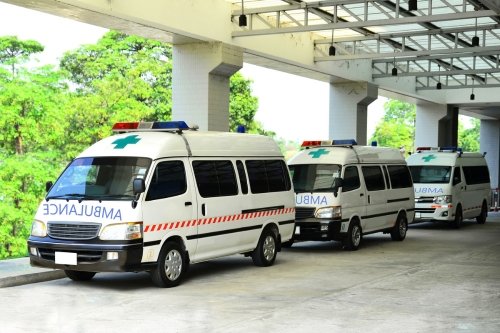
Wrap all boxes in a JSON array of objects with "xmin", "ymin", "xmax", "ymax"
[{"xmin": 293, "ymin": 218, "xmax": 345, "ymax": 241}]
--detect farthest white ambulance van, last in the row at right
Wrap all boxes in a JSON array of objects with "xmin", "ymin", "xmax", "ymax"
[{"xmin": 406, "ymin": 147, "xmax": 491, "ymax": 228}]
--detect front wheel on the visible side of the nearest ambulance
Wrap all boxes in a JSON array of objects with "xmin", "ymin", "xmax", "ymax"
[{"xmin": 151, "ymin": 241, "xmax": 187, "ymax": 288}]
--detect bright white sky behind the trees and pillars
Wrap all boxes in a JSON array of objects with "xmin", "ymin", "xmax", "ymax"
[{"xmin": 0, "ymin": 2, "xmax": 385, "ymax": 142}]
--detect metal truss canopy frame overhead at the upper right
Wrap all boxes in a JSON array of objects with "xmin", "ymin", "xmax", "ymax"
[{"xmin": 226, "ymin": 0, "xmax": 500, "ymax": 90}]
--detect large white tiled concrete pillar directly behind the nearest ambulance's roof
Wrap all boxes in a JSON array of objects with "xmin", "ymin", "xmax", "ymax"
[{"xmin": 172, "ymin": 42, "xmax": 243, "ymax": 131}]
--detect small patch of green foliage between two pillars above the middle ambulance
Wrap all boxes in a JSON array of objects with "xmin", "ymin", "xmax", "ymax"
[{"xmin": 370, "ymin": 100, "xmax": 416, "ymax": 152}]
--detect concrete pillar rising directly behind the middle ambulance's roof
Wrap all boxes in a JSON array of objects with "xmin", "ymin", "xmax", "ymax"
[{"xmin": 329, "ymin": 82, "xmax": 378, "ymax": 145}]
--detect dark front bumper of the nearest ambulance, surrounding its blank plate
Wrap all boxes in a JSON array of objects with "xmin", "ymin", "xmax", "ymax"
[{"xmin": 28, "ymin": 237, "xmax": 147, "ymax": 272}]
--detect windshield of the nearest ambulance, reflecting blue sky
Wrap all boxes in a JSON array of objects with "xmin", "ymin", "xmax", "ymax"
[{"xmin": 47, "ymin": 157, "xmax": 151, "ymax": 200}]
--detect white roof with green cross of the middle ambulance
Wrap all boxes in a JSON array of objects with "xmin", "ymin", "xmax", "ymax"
[{"xmin": 288, "ymin": 145, "xmax": 406, "ymax": 165}]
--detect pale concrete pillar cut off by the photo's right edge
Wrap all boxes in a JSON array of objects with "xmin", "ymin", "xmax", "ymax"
[{"xmin": 479, "ymin": 119, "xmax": 500, "ymax": 188}]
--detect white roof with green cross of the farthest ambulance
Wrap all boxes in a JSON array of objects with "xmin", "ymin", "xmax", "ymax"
[{"xmin": 406, "ymin": 151, "xmax": 486, "ymax": 166}]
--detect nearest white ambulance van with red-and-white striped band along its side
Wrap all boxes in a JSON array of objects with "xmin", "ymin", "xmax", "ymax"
[{"xmin": 28, "ymin": 122, "xmax": 295, "ymax": 287}]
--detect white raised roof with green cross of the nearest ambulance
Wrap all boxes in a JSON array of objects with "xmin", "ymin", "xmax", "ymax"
[{"xmin": 79, "ymin": 130, "xmax": 283, "ymax": 159}]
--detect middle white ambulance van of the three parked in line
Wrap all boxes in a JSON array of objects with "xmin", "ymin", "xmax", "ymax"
[{"xmin": 287, "ymin": 140, "xmax": 415, "ymax": 250}]
